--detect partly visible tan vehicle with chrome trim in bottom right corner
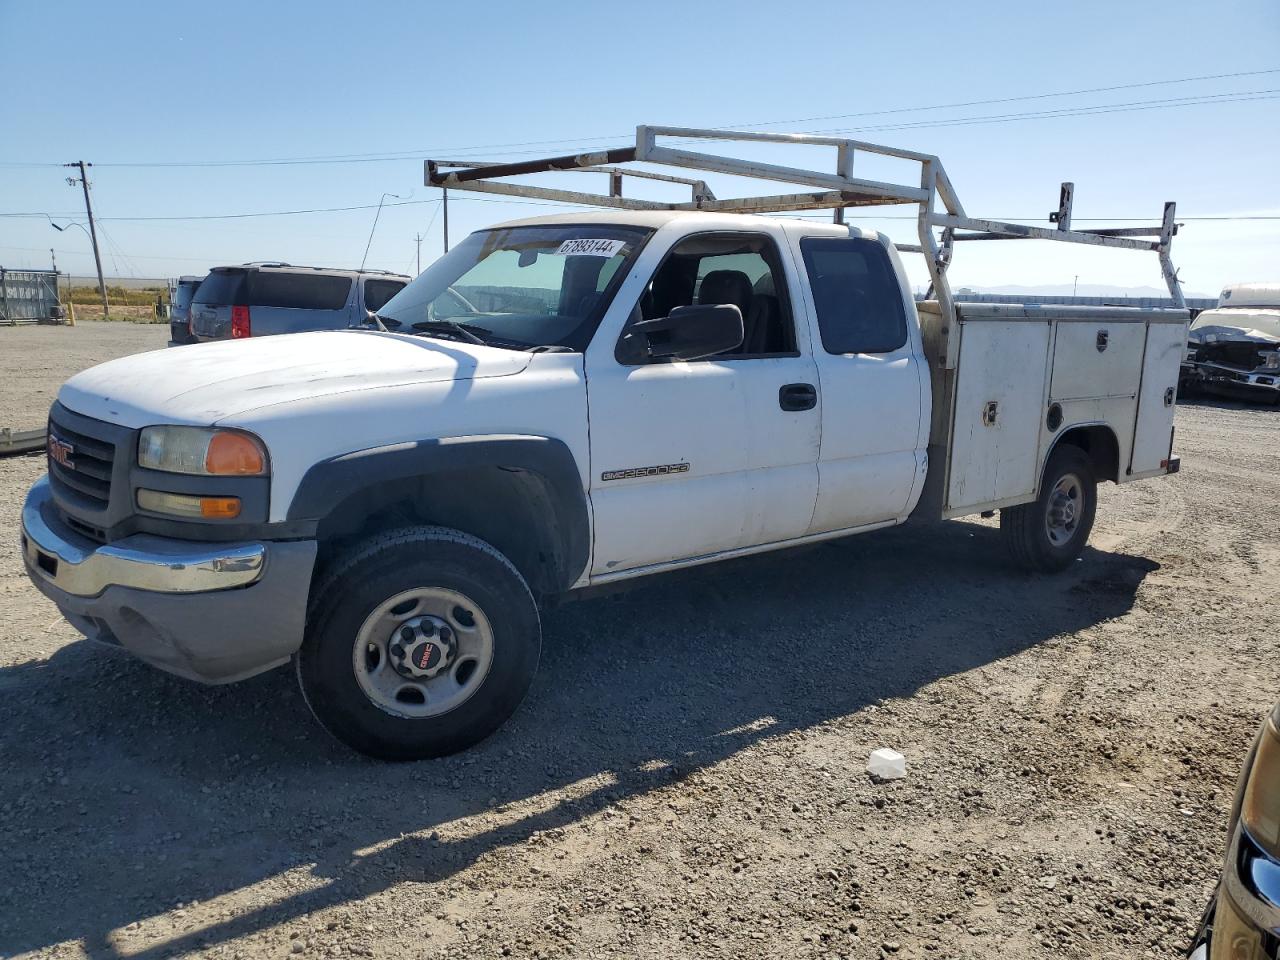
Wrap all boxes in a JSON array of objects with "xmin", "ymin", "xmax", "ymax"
[{"xmin": 1190, "ymin": 704, "xmax": 1280, "ymax": 960}]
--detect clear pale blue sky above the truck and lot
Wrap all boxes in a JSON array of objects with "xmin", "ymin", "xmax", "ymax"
[{"xmin": 0, "ymin": 0, "xmax": 1280, "ymax": 293}]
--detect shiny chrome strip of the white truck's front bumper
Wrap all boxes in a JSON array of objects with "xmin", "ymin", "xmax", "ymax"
[{"xmin": 22, "ymin": 477, "xmax": 266, "ymax": 596}]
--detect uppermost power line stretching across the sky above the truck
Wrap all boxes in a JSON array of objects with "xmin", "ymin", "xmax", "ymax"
[{"xmin": 0, "ymin": 68, "xmax": 1280, "ymax": 168}]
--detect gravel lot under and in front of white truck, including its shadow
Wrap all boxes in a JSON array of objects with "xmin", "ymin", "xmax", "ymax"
[{"xmin": 0, "ymin": 337, "xmax": 1280, "ymax": 960}]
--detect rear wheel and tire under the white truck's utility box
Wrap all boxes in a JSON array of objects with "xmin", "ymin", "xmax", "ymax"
[{"xmin": 1000, "ymin": 444, "xmax": 1098, "ymax": 573}]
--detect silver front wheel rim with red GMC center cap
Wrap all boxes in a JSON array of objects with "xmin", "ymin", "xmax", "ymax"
[{"xmin": 351, "ymin": 586, "xmax": 493, "ymax": 719}]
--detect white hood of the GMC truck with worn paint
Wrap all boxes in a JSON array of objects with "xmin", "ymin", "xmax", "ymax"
[{"xmin": 58, "ymin": 330, "xmax": 532, "ymax": 429}]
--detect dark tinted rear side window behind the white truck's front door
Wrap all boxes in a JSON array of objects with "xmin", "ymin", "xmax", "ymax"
[{"xmin": 800, "ymin": 237, "xmax": 906, "ymax": 353}]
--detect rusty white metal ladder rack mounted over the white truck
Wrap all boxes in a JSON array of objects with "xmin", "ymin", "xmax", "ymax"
[{"xmin": 426, "ymin": 125, "xmax": 1185, "ymax": 367}]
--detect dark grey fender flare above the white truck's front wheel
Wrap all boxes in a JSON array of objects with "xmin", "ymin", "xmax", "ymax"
[{"xmin": 287, "ymin": 434, "xmax": 591, "ymax": 590}]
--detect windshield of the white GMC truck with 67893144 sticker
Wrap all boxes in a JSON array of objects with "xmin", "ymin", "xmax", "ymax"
[{"xmin": 378, "ymin": 224, "xmax": 652, "ymax": 351}]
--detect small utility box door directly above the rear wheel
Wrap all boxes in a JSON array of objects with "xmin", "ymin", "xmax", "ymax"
[{"xmin": 1048, "ymin": 320, "xmax": 1147, "ymax": 401}]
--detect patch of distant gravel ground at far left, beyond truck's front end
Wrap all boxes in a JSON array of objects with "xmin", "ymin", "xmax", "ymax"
[{"xmin": 0, "ymin": 320, "xmax": 169, "ymax": 430}]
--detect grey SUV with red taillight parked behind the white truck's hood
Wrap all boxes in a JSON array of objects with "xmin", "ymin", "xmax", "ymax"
[{"xmin": 191, "ymin": 262, "xmax": 410, "ymax": 342}]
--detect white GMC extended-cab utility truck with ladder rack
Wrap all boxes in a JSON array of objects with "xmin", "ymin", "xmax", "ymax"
[{"xmin": 22, "ymin": 128, "xmax": 1187, "ymax": 758}]
